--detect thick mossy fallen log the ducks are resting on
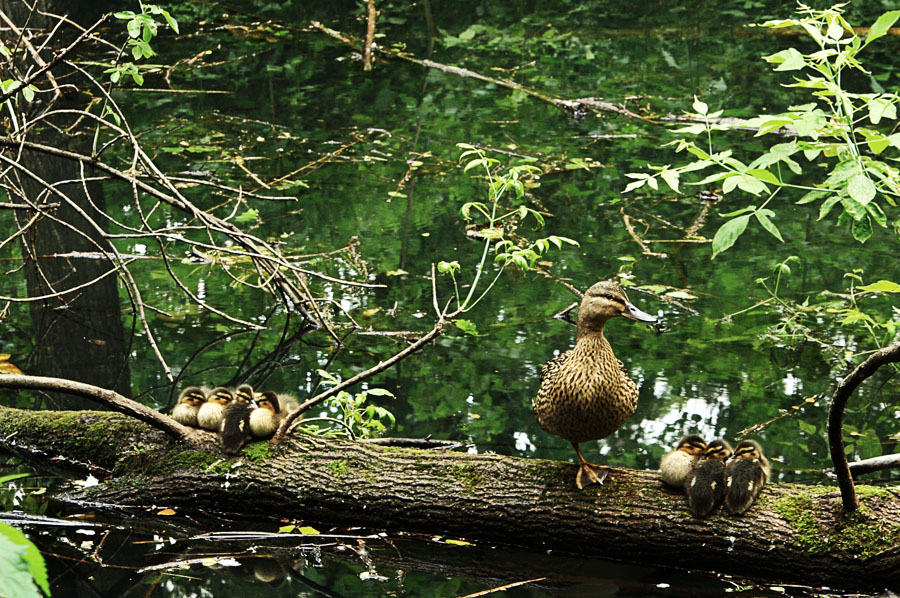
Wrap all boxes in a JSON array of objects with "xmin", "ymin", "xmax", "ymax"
[{"xmin": 0, "ymin": 408, "xmax": 900, "ymax": 588}]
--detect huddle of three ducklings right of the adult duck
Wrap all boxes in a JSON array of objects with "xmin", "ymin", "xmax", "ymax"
[{"xmin": 659, "ymin": 435, "xmax": 771, "ymax": 517}]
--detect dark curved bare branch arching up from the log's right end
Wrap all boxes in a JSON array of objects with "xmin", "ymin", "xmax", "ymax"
[{"xmin": 828, "ymin": 342, "xmax": 900, "ymax": 511}]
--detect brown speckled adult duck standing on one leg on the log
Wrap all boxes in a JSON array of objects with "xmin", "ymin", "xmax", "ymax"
[{"xmin": 534, "ymin": 280, "xmax": 656, "ymax": 489}]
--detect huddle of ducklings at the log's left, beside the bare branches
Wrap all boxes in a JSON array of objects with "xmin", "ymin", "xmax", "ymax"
[{"xmin": 172, "ymin": 384, "xmax": 298, "ymax": 454}]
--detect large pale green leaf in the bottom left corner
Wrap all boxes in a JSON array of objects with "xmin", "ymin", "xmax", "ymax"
[{"xmin": 0, "ymin": 522, "xmax": 50, "ymax": 598}]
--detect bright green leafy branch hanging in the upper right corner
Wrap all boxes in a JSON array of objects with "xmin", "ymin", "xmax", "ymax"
[{"xmin": 625, "ymin": 4, "xmax": 900, "ymax": 257}]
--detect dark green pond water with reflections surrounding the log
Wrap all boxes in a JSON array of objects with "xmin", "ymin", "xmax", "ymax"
[{"xmin": 0, "ymin": 2, "xmax": 900, "ymax": 597}]
